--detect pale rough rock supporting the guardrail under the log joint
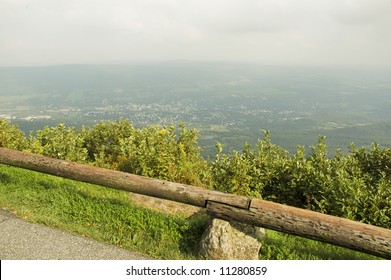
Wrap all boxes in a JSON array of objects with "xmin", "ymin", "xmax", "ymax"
[{"xmin": 199, "ymin": 219, "xmax": 265, "ymax": 260}]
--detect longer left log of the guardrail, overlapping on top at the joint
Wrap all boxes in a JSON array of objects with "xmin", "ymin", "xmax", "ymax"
[{"xmin": 0, "ymin": 148, "xmax": 250, "ymax": 209}]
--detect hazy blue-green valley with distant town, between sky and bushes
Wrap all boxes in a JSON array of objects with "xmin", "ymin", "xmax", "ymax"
[{"xmin": 0, "ymin": 61, "xmax": 391, "ymax": 156}]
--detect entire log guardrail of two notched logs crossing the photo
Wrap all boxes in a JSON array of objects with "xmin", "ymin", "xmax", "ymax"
[{"xmin": 0, "ymin": 148, "xmax": 391, "ymax": 259}]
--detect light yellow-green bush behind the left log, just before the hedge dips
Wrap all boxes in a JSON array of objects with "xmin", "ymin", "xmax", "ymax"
[{"xmin": 118, "ymin": 125, "xmax": 211, "ymax": 186}]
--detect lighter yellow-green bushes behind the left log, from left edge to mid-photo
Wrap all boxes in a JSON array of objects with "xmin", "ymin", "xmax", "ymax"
[{"xmin": 0, "ymin": 119, "xmax": 210, "ymax": 187}]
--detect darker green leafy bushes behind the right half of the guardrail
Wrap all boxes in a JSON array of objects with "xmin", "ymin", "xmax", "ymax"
[{"xmin": 211, "ymin": 133, "xmax": 391, "ymax": 228}]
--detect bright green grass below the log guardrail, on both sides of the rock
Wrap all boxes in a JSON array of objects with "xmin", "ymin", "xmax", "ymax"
[{"xmin": 0, "ymin": 165, "xmax": 375, "ymax": 260}]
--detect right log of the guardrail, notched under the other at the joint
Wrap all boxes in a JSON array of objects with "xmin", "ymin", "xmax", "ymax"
[{"xmin": 206, "ymin": 199, "xmax": 391, "ymax": 259}]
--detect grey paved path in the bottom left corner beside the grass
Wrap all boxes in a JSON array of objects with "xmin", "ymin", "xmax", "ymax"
[{"xmin": 0, "ymin": 209, "xmax": 152, "ymax": 260}]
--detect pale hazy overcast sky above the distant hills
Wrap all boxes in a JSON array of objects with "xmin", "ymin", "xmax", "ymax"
[{"xmin": 0, "ymin": 0, "xmax": 391, "ymax": 66}]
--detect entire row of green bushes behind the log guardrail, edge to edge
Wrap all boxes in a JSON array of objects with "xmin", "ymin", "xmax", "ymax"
[{"xmin": 0, "ymin": 119, "xmax": 391, "ymax": 228}]
